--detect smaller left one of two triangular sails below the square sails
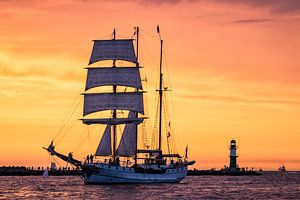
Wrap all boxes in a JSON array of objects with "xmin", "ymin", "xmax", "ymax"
[{"xmin": 95, "ymin": 125, "xmax": 112, "ymax": 156}]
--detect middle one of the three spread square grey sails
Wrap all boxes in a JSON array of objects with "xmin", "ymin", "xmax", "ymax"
[{"xmin": 85, "ymin": 67, "xmax": 143, "ymax": 90}]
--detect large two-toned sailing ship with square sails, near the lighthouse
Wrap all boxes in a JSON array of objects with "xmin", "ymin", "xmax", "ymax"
[{"xmin": 45, "ymin": 27, "xmax": 195, "ymax": 184}]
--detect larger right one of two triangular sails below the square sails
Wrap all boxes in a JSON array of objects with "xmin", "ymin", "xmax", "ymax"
[{"xmin": 117, "ymin": 112, "xmax": 136, "ymax": 156}]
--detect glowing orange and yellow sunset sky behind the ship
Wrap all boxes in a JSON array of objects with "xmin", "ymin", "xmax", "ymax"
[{"xmin": 0, "ymin": 0, "xmax": 300, "ymax": 170}]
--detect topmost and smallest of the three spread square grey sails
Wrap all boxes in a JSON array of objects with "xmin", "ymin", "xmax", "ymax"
[{"xmin": 89, "ymin": 39, "xmax": 137, "ymax": 64}]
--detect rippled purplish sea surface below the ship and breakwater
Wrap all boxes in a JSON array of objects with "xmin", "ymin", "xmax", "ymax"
[{"xmin": 0, "ymin": 172, "xmax": 300, "ymax": 200}]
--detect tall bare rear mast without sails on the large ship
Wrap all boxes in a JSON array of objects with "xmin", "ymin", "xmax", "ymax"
[{"xmin": 157, "ymin": 26, "xmax": 163, "ymax": 151}]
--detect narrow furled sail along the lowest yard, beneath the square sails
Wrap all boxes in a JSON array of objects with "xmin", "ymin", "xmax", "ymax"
[{"xmin": 81, "ymin": 117, "xmax": 144, "ymax": 125}]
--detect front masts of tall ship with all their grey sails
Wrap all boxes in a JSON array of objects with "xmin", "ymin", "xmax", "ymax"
[{"xmin": 82, "ymin": 27, "xmax": 144, "ymax": 163}]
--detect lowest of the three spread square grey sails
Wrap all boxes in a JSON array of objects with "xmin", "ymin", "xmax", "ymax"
[{"xmin": 83, "ymin": 92, "xmax": 144, "ymax": 116}]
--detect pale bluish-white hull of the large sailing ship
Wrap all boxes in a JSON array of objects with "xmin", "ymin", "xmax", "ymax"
[{"xmin": 83, "ymin": 164, "xmax": 187, "ymax": 184}]
